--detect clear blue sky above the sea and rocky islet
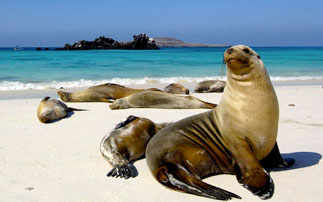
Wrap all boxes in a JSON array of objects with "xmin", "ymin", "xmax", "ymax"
[{"xmin": 0, "ymin": 0, "xmax": 323, "ymax": 47}]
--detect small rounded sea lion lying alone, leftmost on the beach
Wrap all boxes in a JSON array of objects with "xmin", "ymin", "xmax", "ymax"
[{"xmin": 37, "ymin": 97, "xmax": 85, "ymax": 123}]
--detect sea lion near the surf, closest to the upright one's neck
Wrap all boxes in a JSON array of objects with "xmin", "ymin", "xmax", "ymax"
[{"xmin": 194, "ymin": 80, "xmax": 225, "ymax": 93}]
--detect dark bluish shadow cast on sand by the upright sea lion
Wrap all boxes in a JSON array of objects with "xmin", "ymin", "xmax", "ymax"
[{"xmin": 271, "ymin": 152, "xmax": 322, "ymax": 172}]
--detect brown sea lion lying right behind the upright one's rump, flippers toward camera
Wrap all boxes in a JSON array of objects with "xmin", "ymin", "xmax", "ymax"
[{"xmin": 100, "ymin": 116, "xmax": 168, "ymax": 179}]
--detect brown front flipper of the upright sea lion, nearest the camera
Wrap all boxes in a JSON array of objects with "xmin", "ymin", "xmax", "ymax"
[{"xmin": 230, "ymin": 138, "xmax": 275, "ymax": 199}]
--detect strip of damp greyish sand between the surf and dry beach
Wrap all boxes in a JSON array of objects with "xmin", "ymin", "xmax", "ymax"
[{"xmin": 0, "ymin": 80, "xmax": 323, "ymax": 100}]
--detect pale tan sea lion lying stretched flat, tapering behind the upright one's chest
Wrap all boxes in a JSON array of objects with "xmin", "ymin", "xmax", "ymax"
[{"xmin": 109, "ymin": 91, "xmax": 216, "ymax": 110}]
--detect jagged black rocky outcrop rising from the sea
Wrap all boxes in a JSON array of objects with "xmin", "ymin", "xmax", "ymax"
[{"xmin": 56, "ymin": 34, "xmax": 159, "ymax": 50}]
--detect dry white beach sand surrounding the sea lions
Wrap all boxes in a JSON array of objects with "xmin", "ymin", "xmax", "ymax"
[{"xmin": 0, "ymin": 85, "xmax": 323, "ymax": 202}]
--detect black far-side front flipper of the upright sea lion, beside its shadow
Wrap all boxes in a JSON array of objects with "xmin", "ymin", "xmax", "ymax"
[{"xmin": 260, "ymin": 142, "xmax": 295, "ymax": 169}]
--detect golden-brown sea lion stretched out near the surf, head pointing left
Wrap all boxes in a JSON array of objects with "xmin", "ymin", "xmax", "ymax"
[{"xmin": 57, "ymin": 83, "xmax": 161, "ymax": 103}]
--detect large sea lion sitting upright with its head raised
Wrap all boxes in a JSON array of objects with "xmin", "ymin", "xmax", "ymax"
[{"xmin": 146, "ymin": 45, "xmax": 296, "ymax": 200}]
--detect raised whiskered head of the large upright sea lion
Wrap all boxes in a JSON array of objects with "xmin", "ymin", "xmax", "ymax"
[{"xmin": 224, "ymin": 45, "xmax": 263, "ymax": 80}]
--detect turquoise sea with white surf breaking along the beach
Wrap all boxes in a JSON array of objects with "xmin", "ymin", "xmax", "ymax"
[{"xmin": 0, "ymin": 47, "xmax": 323, "ymax": 90}]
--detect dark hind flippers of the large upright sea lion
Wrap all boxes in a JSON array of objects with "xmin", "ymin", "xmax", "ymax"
[{"xmin": 156, "ymin": 165, "xmax": 241, "ymax": 200}]
